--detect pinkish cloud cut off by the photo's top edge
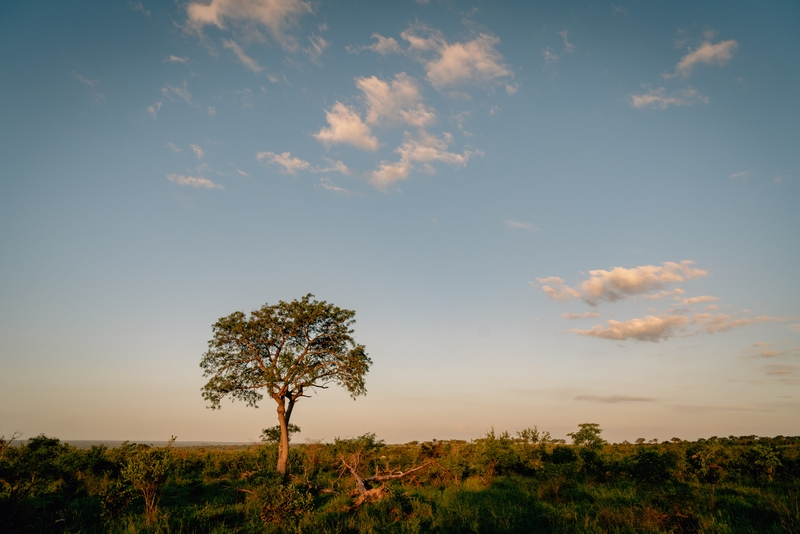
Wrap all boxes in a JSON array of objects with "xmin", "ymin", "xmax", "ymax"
[{"xmin": 186, "ymin": 0, "xmax": 312, "ymax": 49}]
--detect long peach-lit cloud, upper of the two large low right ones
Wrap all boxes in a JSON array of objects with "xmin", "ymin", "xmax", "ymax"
[{"xmin": 536, "ymin": 261, "xmax": 708, "ymax": 306}]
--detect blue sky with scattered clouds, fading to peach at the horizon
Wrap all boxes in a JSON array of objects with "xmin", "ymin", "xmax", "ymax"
[{"xmin": 0, "ymin": 0, "xmax": 800, "ymax": 443}]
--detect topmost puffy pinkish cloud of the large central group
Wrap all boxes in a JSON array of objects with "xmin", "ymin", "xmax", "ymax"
[{"xmin": 401, "ymin": 25, "xmax": 513, "ymax": 89}]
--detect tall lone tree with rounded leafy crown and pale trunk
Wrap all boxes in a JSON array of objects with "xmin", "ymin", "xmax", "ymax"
[{"xmin": 200, "ymin": 293, "xmax": 372, "ymax": 475}]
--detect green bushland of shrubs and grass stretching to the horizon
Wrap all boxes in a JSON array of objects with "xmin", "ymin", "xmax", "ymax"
[{"xmin": 0, "ymin": 430, "xmax": 800, "ymax": 533}]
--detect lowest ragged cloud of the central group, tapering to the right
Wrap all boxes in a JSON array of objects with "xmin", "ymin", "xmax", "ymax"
[{"xmin": 369, "ymin": 131, "xmax": 482, "ymax": 189}]
